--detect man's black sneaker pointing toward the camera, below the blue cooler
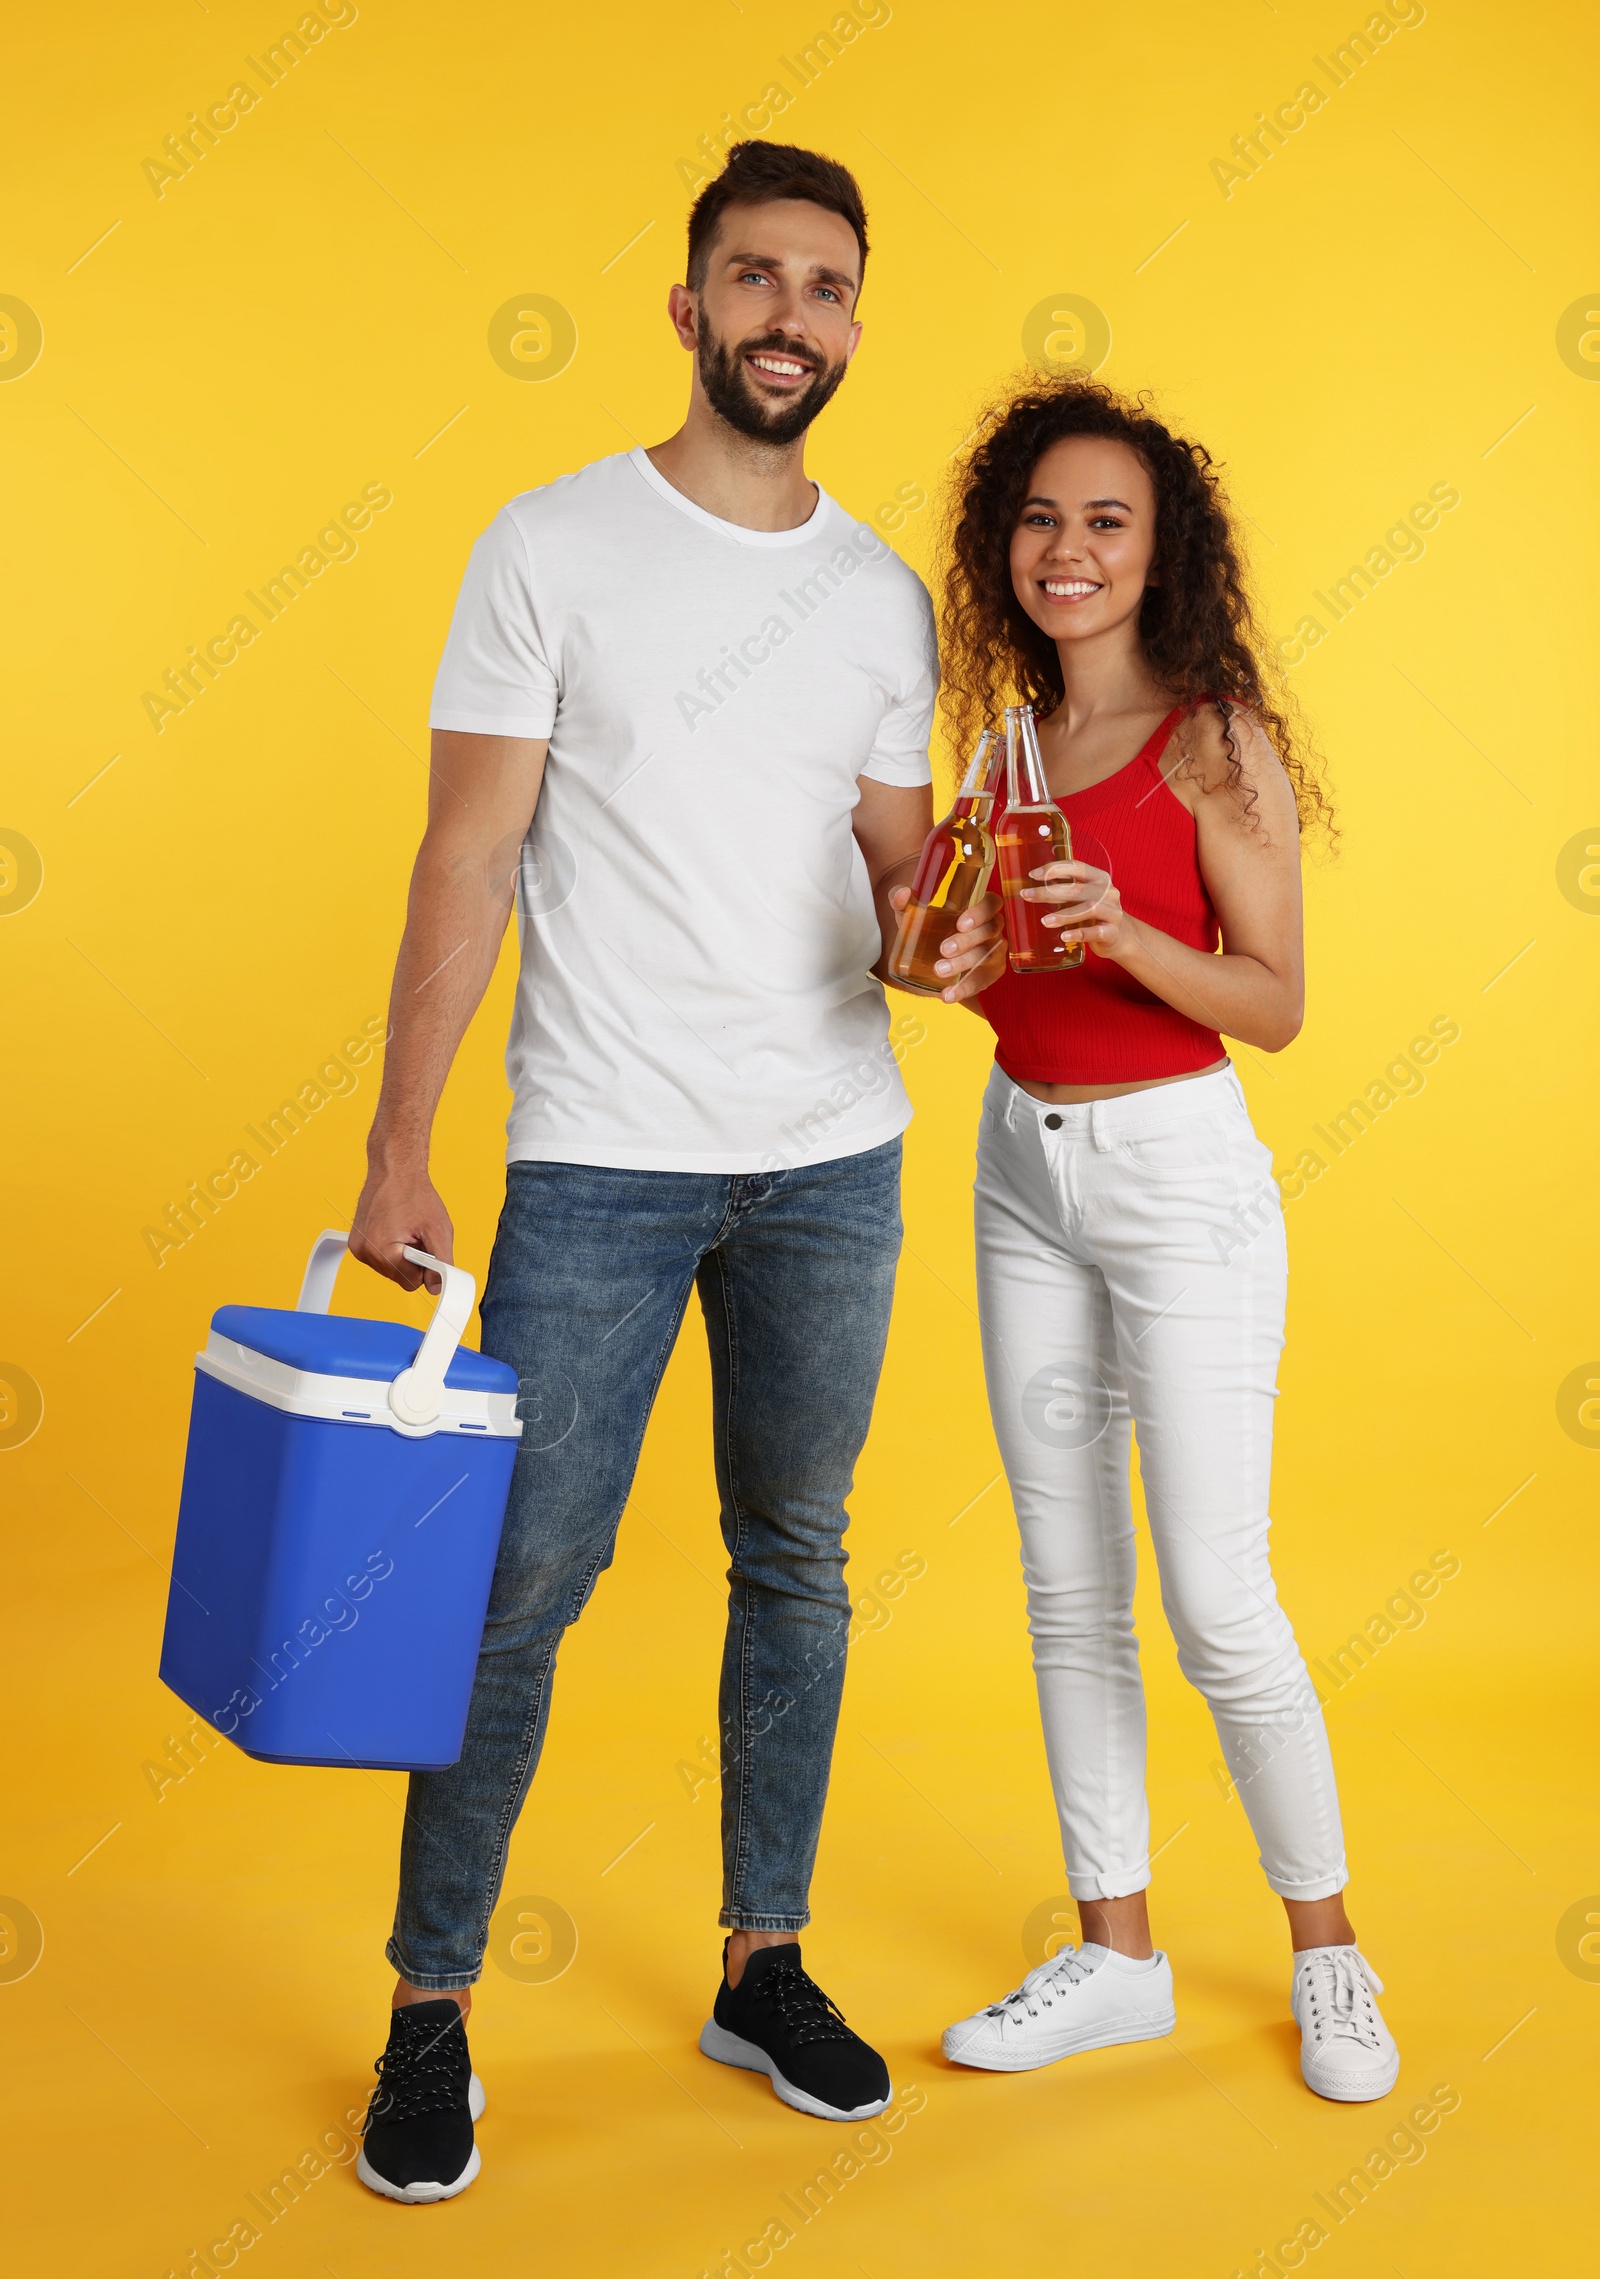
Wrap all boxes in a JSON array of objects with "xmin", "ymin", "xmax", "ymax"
[{"xmin": 356, "ymin": 1994, "xmax": 483, "ymax": 2206}]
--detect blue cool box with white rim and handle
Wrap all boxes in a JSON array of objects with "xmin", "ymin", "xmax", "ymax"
[{"xmin": 162, "ymin": 1233, "xmax": 522, "ymax": 1771}]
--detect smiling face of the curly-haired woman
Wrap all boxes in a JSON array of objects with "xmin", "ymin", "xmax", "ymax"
[{"xmin": 1012, "ymin": 435, "xmax": 1160, "ymax": 643}]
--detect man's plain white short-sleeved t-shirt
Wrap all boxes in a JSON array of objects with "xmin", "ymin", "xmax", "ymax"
[{"xmin": 431, "ymin": 449, "xmax": 937, "ymax": 1171}]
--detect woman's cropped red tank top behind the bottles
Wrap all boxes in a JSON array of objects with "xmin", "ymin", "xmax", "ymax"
[{"xmin": 978, "ymin": 704, "xmax": 1222, "ymax": 1085}]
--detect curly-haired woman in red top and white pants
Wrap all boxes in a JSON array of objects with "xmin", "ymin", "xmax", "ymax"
[{"xmin": 920, "ymin": 376, "xmax": 1399, "ymax": 2101}]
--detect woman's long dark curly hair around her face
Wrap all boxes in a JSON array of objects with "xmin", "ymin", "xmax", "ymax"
[{"xmin": 939, "ymin": 371, "xmax": 1333, "ymax": 836}]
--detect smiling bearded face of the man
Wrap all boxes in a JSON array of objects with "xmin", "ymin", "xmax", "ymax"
[{"xmin": 672, "ymin": 198, "xmax": 862, "ymax": 444}]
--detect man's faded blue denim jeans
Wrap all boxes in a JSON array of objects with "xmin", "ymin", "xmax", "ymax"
[{"xmin": 387, "ymin": 1140, "xmax": 900, "ymax": 1992}]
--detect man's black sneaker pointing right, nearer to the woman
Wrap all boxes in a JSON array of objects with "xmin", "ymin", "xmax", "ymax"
[{"xmin": 700, "ymin": 1944, "xmax": 893, "ymax": 2122}]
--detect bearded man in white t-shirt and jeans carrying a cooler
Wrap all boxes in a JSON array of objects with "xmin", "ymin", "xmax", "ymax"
[{"xmin": 351, "ymin": 144, "xmax": 998, "ymax": 2202}]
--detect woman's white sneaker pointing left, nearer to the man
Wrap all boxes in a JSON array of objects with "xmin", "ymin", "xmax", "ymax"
[{"xmin": 944, "ymin": 1942, "xmax": 1178, "ymax": 2074}]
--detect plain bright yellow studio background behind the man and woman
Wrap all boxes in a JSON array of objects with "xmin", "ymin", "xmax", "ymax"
[{"xmin": 0, "ymin": 0, "xmax": 1600, "ymax": 2279}]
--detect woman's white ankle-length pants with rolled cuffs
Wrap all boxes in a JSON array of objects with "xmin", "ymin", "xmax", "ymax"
[{"xmin": 978, "ymin": 1066, "xmax": 1345, "ymax": 1898}]
